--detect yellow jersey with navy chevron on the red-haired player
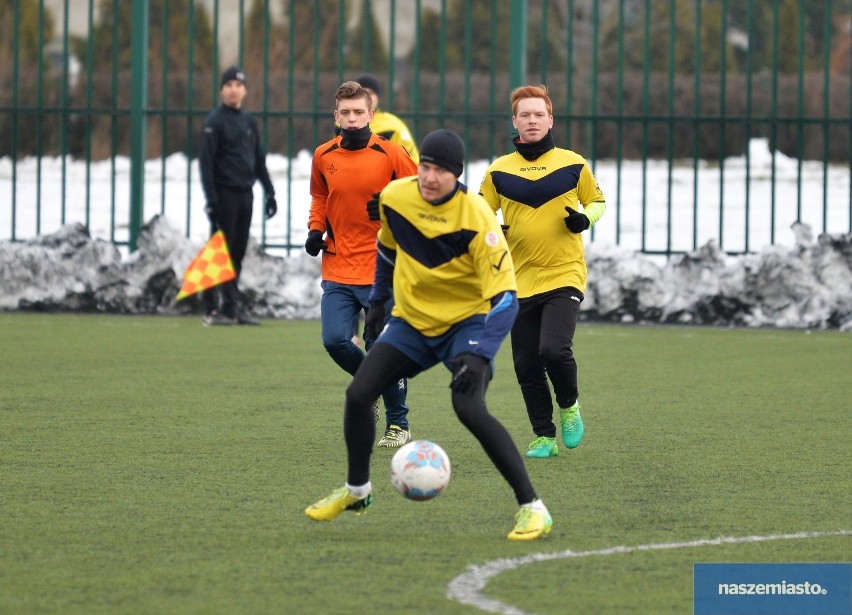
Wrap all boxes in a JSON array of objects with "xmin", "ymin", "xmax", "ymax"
[{"xmin": 479, "ymin": 147, "xmax": 605, "ymax": 299}]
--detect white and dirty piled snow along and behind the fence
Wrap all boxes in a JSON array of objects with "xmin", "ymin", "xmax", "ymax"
[{"xmin": 0, "ymin": 140, "xmax": 852, "ymax": 330}]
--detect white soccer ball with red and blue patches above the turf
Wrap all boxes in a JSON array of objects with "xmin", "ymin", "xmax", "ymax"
[{"xmin": 391, "ymin": 440, "xmax": 450, "ymax": 501}]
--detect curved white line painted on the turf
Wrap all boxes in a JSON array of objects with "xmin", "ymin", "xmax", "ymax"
[{"xmin": 447, "ymin": 530, "xmax": 852, "ymax": 615}]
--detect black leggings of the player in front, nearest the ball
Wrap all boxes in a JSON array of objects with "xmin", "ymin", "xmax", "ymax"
[{"xmin": 343, "ymin": 342, "xmax": 537, "ymax": 504}]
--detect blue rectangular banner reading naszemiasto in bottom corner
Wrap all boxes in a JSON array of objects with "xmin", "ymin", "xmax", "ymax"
[{"xmin": 692, "ymin": 563, "xmax": 852, "ymax": 615}]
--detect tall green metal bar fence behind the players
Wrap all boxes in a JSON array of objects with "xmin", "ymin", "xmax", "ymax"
[{"xmin": 0, "ymin": 0, "xmax": 852, "ymax": 255}]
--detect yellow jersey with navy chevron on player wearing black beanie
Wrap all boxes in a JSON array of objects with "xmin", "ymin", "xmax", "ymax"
[{"xmin": 378, "ymin": 177, "xmax": 517, "ymax": 337}]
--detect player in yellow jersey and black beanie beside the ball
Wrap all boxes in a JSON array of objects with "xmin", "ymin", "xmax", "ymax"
[{"xmin": 305, "ymin": 129, "xmax": 553, "ymax": 540}]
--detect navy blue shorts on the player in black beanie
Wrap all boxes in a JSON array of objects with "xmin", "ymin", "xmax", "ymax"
[{"xmin": 376, "ymin": 314, "xmax": 494, "ymax": 378}]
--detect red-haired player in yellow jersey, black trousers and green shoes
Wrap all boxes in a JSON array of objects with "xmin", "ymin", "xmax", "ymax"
[{"xmin": 479, "ymin": 85, "xmax": 606, "ymax": 458}]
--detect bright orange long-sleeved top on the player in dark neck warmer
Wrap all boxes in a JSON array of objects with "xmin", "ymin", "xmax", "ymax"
[{"xmin": 308, "ymin": 134, "xmax": 417, "ymax": 285}]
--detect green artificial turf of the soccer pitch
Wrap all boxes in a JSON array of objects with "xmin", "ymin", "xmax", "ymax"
[{"xmin": 0, "ymin": 313, "xmax": 852, "ymax": 614}]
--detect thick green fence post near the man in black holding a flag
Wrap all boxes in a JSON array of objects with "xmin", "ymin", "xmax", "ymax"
[{"xmin": 127, "ymin": 0, "xmax": 148, "ymax": 252}]
